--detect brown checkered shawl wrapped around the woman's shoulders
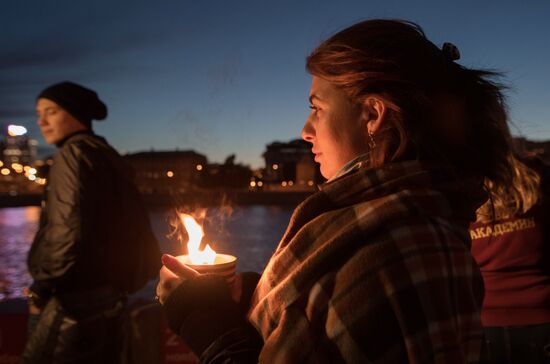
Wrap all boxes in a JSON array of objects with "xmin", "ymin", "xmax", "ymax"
[{"xmin": 249, "ymin": 162, "xmax": 484, "ymax": 364}]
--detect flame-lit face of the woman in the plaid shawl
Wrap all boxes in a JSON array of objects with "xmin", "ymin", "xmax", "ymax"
[{"xmin": 302, "ymin": 76, "xmax": 369, "ymax": 179}]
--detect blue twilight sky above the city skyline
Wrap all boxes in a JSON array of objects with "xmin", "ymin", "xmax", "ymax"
[{"xmin": 0, "ymin": 0, "xmax": 550, "ymax": 167}]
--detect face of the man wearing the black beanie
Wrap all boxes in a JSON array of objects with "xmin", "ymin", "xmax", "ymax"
[{"xmin": 36, "ymin": 98, "xmax": 87, "ymax": 144}]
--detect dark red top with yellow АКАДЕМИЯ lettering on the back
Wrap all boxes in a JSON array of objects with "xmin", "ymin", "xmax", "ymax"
[{"xmin": 470, "ymin": 200, "xmax": 550, "ymax": 327}]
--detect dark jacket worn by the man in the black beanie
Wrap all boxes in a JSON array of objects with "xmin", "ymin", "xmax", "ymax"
[{"xmin": 28, "ymin": 132, "xmax": 160, "ymax": 301}]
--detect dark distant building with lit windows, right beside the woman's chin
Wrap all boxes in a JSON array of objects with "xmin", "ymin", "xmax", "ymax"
[{"xmin": 264, "ymin": 139, "xmax": 323, "ymax": 190}]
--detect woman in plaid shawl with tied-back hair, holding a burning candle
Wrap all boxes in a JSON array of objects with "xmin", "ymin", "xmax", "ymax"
[{"xmin": 157, "ymin": 20, "xmax": 511, "ymax": 363}]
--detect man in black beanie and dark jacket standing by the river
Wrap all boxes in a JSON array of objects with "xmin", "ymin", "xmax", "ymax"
[{"xmin": 22, "ymin": 82, "xmax": 160, "ymax": 363}]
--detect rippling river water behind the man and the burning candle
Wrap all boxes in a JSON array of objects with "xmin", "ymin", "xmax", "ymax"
[{"xmin": 0, "ymin": 206, "xmax": 293, "ymax": 301}]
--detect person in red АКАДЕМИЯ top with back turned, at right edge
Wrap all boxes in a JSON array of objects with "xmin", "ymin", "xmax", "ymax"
[{"xmin": 470, "ymin": 158, "xmax": 550, "ymax": 363}]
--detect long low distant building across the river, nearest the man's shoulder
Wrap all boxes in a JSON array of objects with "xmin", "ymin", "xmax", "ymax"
[{"xmin": 125, "ymin": 151, "xmax": 208, "ymax": 194}]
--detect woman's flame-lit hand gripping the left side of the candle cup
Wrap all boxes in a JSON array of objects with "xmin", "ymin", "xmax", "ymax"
[{"xmin": 157, "ymin": 254, "xmax": 200, "ymax": 304}]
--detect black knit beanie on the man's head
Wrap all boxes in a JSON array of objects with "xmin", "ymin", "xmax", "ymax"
[{"xmin": 37, "ymin": 81, "xmax": 107, "ymax": 126}]
